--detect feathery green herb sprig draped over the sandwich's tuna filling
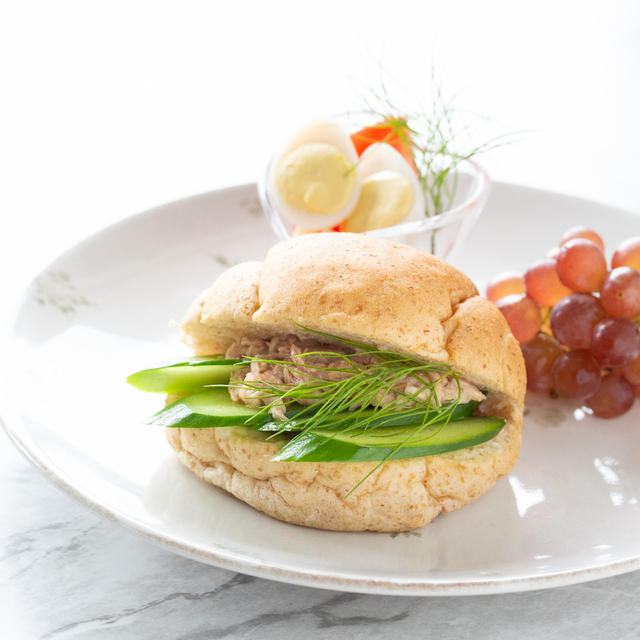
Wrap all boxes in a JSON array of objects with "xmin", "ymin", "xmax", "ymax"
[{"xmin": 229, "ymin": 327, "xmax": 461, "ymax": 495}]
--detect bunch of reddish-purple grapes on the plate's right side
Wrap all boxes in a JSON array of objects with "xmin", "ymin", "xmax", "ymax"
[{"xmin": 487, "ymin": 227, "xmax": 640, "ymax": 418}]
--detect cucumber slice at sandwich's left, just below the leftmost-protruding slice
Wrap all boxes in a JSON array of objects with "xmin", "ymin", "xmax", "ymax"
[{"xmin": 147, "ymin": 387, "xmax": 258, "ymax": 429}]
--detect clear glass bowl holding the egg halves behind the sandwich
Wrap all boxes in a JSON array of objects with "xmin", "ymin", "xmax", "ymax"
[{"xmin": 258, "ymin": 159, "xmax": 491, "ymax": 259}]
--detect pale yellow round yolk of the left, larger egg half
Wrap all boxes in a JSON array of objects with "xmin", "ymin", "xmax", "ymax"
[{"xmin": 275, "ymin": 142, "xmax": 356, "ymax": 215}]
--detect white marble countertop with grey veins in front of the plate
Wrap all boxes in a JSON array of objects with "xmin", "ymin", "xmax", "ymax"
[{"xmin": 0, "ymin": 424, "xmax": 640, "ymax": 640}]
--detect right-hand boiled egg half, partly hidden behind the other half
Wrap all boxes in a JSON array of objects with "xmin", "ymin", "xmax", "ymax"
[{"xmin": 342, "ymin": 142, "xmax": 425, "ymax": 233}]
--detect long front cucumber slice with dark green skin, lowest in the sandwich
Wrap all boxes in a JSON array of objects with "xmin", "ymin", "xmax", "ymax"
[{"xmin": 273, "ymin": 416, "xmax": 505, "ymax": 462}]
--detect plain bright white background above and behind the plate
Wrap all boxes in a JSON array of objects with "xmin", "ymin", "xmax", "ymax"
[{"xmin": 0, "ymin": 0, "xmax": 640, "ymax": 304}]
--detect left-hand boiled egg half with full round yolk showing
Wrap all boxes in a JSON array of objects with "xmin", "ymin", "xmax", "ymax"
[{"xmin": 268, "ymin": 121, "xmax": 360, "ymax": 231}]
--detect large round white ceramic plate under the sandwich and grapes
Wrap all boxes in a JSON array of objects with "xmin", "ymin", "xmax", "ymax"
[{"xmin": 0, "ymin": 184, "xmax": 640, "ymax": 595}]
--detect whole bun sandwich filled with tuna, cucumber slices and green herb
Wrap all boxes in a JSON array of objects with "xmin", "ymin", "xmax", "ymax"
[{"xmin": 129, "ymin": 233, "xmax": 526, "ymax": 532}]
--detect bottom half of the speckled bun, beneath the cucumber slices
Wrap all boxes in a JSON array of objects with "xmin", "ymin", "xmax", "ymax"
[{"xmin": 166, "ymin": 398, "xmax": 522, "ymax": 532}]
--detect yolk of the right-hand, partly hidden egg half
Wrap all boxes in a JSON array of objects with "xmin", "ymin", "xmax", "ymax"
[{"xmin": 344, "ymin": 171, "xmax": 414, "ymax": 233}]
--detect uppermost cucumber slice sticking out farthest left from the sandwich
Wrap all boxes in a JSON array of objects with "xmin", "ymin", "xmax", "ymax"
[{"xmin": 127, "ymin": 358, "xmax": 243, "ymax": 393}]
